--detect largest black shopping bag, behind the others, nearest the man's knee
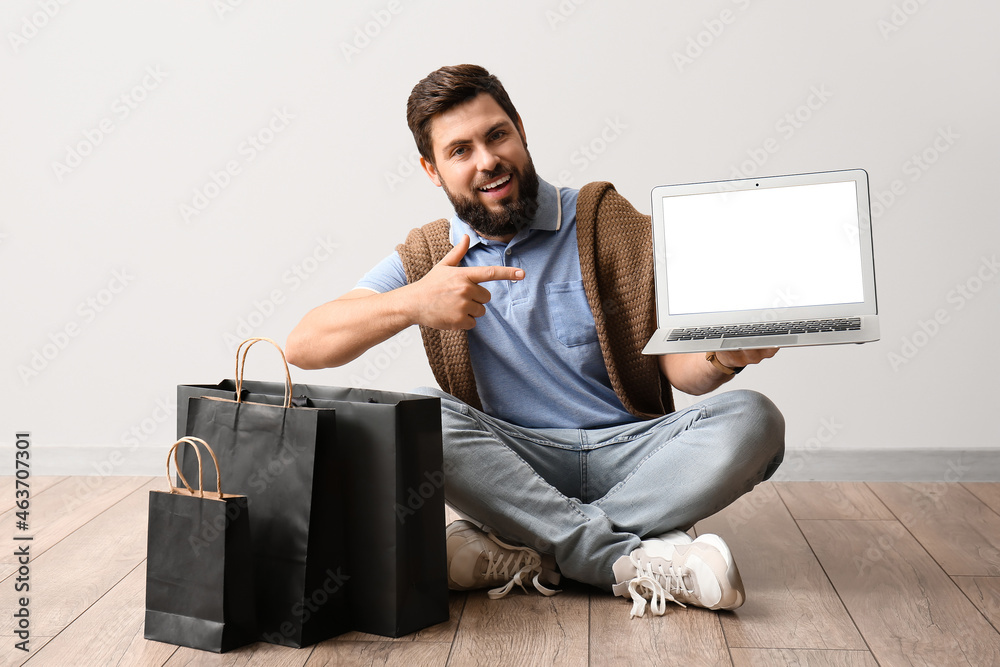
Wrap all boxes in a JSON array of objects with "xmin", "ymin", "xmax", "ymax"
[{"xmin": 177, "ymin": 342, "xmax": 448, "ymax": 637}]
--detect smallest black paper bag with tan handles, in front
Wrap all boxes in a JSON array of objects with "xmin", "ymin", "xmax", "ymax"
[{"xmin": 143, "ymin": 438, "xmax": 257, "ymax": 653}]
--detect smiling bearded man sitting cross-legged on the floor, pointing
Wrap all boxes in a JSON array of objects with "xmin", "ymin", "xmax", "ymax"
[{"xmin": 287, "ymin": 65, "xmax": 784, "ymax": 616}]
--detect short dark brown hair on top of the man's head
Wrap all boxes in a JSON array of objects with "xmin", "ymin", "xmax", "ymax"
[{"xmin": 406, "ymin": 65, "xmax": 524, "ymax": 164}]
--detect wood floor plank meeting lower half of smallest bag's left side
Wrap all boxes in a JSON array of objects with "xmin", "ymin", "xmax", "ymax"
[{"xmin": 27, "ymin": 562, "xmax": 177, "ymax": 667}]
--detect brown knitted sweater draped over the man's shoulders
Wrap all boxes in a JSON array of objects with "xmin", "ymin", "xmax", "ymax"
[{"xmin": 396, "ymin": 183, "xmax": 674, "ymax": 419}]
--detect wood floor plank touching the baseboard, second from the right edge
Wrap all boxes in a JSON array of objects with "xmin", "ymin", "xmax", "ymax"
[{"xmin": 868, "ymin": 482, "xmax": 1000, "ymax": 576}]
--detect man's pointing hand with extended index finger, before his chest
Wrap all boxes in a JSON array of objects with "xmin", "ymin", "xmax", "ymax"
[{"xmin": 411, "ymin": 235, "xmax": 524, "ymax": 330}]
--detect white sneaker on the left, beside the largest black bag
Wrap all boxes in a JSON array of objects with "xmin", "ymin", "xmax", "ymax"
[{"xmin": 445, "ymin": 519, "xmax": 560, "ymax": 600}]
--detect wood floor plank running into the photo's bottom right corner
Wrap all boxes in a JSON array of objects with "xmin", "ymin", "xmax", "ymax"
[{"xmin": 799, "ymin": 520, "xmax": 1000, "ymax": 667}]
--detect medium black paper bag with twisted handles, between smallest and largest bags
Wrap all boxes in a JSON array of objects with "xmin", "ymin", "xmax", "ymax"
[{"xmin": 181, "ymin": 339, "xmax": 350, "ymax": 647}]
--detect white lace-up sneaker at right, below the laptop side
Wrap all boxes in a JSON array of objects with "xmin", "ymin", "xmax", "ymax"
[{"xmin": 612, "ymin": 531, "xmax": 745, "ymax": 618}]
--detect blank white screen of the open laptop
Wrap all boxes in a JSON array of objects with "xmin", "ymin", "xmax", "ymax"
[{"xmin": 661, "ymin": 181, "xmax": 864, "ymax": 315}]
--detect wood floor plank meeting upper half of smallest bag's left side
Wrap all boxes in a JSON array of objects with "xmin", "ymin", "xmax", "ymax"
[{"xmin": 0, "ymin": 477, "xmax": 166, "ymax": 641}]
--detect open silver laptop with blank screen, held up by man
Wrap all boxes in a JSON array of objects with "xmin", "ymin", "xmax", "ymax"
[{"xmin": 643, "ymin": 169, "xmax": 879, "ymax": 354}]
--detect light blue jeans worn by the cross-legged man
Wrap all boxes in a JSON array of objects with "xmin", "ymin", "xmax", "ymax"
[{"xmin": 416, "ymin": 387, "xmax": 785, "ymax": 590}]
